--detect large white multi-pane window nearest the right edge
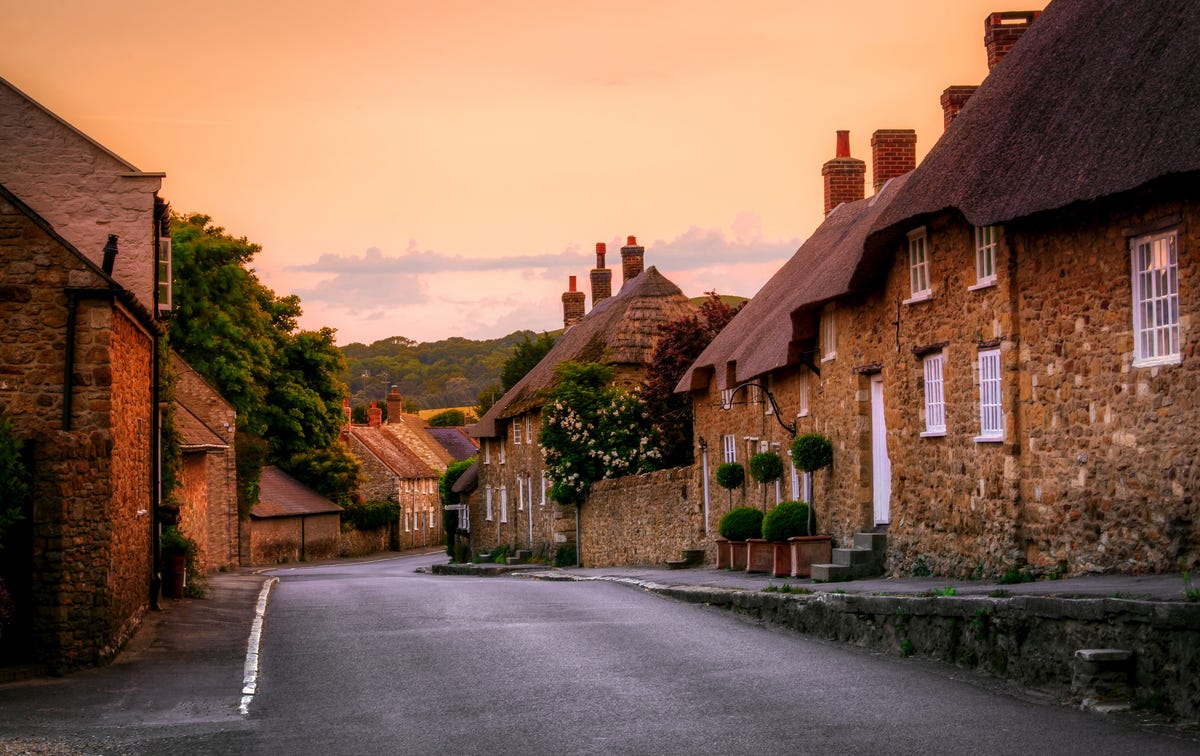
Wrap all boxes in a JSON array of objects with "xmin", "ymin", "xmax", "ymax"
[{"xmin": 1130, "ymin": 229, "xmax": 1182, "ymax": 366}]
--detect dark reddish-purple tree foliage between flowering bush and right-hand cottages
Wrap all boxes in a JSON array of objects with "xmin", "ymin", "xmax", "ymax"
[{"xmin": 641, "ymin": 292, "xmax": 738, "ymax": 467}]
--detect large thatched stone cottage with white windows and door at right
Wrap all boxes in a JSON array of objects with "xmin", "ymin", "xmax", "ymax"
[{"xmin": 679, "ymin": 0, "xmax": 1200, "ymax": 575}]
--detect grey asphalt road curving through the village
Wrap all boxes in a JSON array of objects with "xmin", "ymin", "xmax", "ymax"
[{"xmin": 0, "ymin": 557, "xmax": 1196, "ymax": 755}]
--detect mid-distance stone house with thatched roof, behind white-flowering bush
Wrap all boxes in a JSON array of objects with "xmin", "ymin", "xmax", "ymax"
[{"xmin": 460, "ymin": 236, "xmax": 696, "ymax": 564}]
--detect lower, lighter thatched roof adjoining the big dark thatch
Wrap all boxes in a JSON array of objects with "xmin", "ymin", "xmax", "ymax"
[{"xmin": 676, "ymin": 174, "xmax": 911, "ymax": 391}]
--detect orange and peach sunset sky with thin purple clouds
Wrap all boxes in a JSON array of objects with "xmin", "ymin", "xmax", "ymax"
[{"xmin": 0, "ymin": 0, "xmax": 1045, "ymax": 344}]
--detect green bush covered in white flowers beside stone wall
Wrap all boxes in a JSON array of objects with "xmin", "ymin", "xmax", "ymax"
[{"xmin": 541, "ymin": 362, "xmax": 662, "ymax": 504}]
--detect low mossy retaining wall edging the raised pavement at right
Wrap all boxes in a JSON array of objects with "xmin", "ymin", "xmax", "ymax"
[{"xmin": 656, "ymin": 587, "xmax": 1200, "ymax": 719}]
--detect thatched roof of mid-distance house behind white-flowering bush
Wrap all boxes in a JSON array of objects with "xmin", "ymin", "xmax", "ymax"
[{"xmin": 468, "ymin": 266, "xmax": 697, "ymax": 438}]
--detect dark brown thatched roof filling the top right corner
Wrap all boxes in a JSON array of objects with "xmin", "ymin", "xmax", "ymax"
[{"xmin": 864, "ymin": 0, "xmax": 1200, "ymax": 258}]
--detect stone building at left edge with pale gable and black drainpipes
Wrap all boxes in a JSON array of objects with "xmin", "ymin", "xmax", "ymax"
[{"xmin": 0, "ymin": 79, "xmax": 170, "ymax": 671}]
